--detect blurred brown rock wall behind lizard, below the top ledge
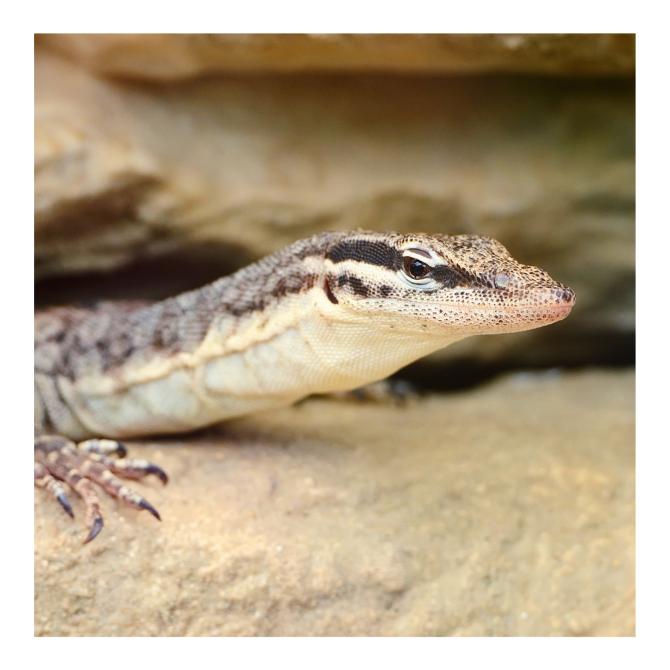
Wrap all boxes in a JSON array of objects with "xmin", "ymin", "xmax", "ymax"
[{"xmin": 35, "ymin": 44, "xmax": 634, "ymax": 363}]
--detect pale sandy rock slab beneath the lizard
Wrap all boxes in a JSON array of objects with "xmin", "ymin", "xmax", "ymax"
[{"xmin": 35, "ymin": 372, "xmax": 635, "ymax": 635}]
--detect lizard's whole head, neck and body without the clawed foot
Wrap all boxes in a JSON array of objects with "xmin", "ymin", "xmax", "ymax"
[{"xmin": 35, "ymin": 231, "xmax": 575, "ymax": 440}]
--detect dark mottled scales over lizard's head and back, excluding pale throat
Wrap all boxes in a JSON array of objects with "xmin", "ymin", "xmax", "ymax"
[{"xmin": 35, "ymin": 231, "xmax": 574, "ymax": 434}]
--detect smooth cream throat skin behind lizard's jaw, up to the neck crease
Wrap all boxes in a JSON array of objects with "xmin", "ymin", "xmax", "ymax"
[{"xmin": 195, "ymin": 284, "xmax": 459, "ymax": 404}]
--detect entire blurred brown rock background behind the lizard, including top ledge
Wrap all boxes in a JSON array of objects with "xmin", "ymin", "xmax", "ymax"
[{"xmin": 35, "ymin": 35, "xmax": 635, "ymax": 387}]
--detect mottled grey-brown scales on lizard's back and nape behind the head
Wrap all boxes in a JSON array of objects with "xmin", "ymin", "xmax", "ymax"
[{"xmin": 35, "ymin": 233, "xmax": 350, "ymax": 386}]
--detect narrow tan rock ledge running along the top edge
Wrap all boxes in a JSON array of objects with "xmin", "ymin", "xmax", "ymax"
[{"xmin": 37, "ymin": 34, "xmax": 635, "ymax": 80}]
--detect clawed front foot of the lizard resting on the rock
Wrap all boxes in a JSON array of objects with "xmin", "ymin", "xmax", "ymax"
[{"xmin": 35, "ymin": 435, "xmax": 168, "ymax": 544}]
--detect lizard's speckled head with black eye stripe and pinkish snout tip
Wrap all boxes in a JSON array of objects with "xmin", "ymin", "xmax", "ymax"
[{"xmin": 324, "ymin": 232, "xmax": 575, "ymax": 338}]
